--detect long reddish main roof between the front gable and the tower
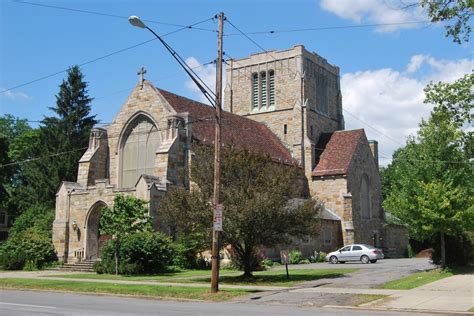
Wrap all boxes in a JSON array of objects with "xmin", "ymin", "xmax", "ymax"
[{"xmin": 156, "ymin": 88, "xmax": 293, "ymax": 164}]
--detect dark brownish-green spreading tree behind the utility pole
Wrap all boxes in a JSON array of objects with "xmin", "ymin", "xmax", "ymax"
[{"xmin": 161, "ymin": 146, "xmax": 321, "ymax": 276}]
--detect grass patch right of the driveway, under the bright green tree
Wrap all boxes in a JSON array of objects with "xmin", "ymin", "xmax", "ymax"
[{"xmin": 382, "ymin": 267, "xmax": 474, "ymax": 290}]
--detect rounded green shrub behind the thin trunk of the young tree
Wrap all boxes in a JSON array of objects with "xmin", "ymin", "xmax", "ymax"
[{"xmin": 98, "ymin": 232, "xmax": 175, "ymax": 274}]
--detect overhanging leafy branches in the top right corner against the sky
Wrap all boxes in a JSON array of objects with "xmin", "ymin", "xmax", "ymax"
[{"xmin": 420, "ymin": 0, "xmax": 474, "ymax": 44}]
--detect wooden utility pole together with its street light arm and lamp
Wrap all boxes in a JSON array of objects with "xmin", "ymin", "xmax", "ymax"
[{"xmin": 128, "ymin": 12, "xmax": 224, "ymax": 293}]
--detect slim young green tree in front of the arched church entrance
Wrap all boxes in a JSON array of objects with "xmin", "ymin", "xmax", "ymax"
[{"xmin": 100, "ymin": 194, "xmax": 152, "ymax": 274}]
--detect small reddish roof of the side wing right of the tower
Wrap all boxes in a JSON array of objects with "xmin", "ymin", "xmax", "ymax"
[{"xmin": 312, "ymin": 129, "xmax": 364, "ymax": 177}]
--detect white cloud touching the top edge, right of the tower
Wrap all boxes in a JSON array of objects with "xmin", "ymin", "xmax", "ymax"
[{"xmin": 320, "ymin": 0, "xmax": 427, "ymax": 32}]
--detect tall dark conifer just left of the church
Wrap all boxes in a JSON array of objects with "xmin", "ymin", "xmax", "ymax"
[{"xmin": 16, "ymin": 66, "xmax": 97, "ymax": 209}]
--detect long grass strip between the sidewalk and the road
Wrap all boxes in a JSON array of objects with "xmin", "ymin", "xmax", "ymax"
[{"xmin": 0, "ymin": 279, "xmax": 255, "ymax": 301}]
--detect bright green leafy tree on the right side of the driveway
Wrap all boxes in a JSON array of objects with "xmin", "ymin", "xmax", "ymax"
[{"xmin": 384, "ymin": 74, "xmax": 474, "ymax": 265}]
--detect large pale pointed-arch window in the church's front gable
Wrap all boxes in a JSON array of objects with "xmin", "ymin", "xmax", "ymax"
[{"xmin": 120, "ymin": 115, "xmax": 160, "ymax": 188}]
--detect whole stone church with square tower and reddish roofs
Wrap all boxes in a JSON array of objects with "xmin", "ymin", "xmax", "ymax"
[{"xmin": 53, "ymin": 45, "xmax": 408, "ymax": 261}]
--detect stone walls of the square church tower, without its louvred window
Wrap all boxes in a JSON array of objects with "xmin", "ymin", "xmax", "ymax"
[{"xmin": 225, "ymin": 45, "xmax": 344, "ymax": 169}]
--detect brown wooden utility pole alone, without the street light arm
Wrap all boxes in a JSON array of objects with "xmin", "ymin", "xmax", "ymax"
[{"xmin": 211, "ymin": 12, "xmax": 224, "ymax": 293}]
